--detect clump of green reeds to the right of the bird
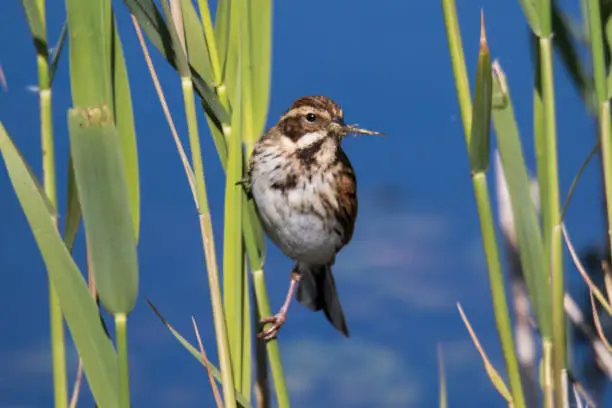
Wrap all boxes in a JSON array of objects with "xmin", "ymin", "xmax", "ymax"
[{"xmin": 442, "ymin": 0, "xmax": 612, "ymax": 407}]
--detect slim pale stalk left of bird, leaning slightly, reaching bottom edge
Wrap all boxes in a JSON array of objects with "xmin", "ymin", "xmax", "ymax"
[{"xmin": 181, "ymin": 76, "xmax": 236, "ymax": 408}]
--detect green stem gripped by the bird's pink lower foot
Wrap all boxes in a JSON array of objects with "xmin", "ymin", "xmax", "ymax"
[{"xmin": 252, "ymin": 269, "xmax": 290, "ymax": 408}]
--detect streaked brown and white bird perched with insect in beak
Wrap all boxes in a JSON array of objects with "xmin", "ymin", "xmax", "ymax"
[{"xmin": 242, "ymin": 96, "xmax": 381, "ymax": 340}]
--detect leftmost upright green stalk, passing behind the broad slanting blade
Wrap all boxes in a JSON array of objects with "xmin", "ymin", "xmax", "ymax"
[{"xmin": 36, "ymin": 0, "xmax": 68, "ymax": 408}]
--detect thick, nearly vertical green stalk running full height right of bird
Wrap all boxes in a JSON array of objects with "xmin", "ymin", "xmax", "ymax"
[{"xmin": 538, "ymin": 0, "xmax": 566, "ymax": 402}]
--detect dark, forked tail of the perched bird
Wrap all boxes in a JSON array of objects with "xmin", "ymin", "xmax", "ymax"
[{"xmin": 296, "ymin": 263, "xmax": 349, "ymax": 337}]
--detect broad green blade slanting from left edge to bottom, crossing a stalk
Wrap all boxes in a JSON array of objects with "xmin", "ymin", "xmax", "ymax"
[{"xmin": 0, "ymin": 124, "xmax": 118, "ymax": 407}]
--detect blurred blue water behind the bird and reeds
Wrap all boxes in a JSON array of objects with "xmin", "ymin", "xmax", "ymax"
[{"xmin": 0, "ymin": 0, "xmax": 604, "ymax": 408}]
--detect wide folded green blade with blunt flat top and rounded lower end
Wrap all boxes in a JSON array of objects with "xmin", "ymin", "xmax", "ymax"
[{"xmin": 68, "ymin": 108, "xmax": 138, "ymax": 314}]
